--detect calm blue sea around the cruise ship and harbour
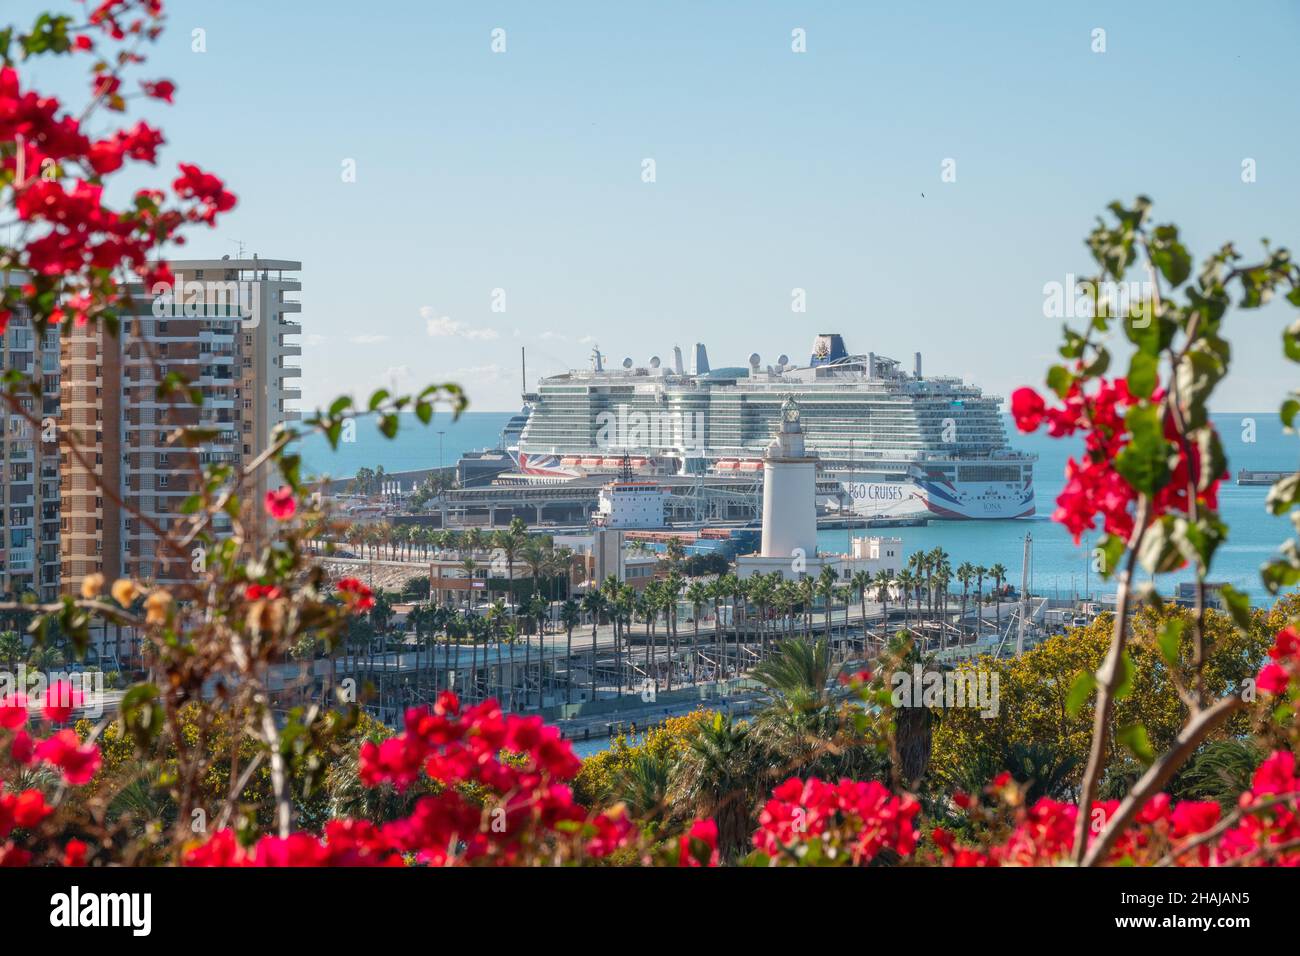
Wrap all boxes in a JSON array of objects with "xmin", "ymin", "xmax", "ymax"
[{"xmin": 302, "ymin": 412, "xmax": 1300, "ymax": 605}]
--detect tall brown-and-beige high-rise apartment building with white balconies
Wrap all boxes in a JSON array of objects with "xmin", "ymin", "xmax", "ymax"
[{"xmin": 61, "ymin": 256, "xmax": 302, "ymax": 591}]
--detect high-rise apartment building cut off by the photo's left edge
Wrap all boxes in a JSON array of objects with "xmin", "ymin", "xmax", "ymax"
[{"xmin": 0, "ymin": 276, "xmax": 60, "ymax": 601}]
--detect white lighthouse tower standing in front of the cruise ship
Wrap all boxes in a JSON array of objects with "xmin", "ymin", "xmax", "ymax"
[{"xmin": 762, "ymin": 398, "xmax": 816, "ymax": 559}]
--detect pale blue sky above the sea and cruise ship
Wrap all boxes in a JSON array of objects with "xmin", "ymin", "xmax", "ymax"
[{"xmin": 15, "ymin": 0, "xmax": 1300, "ymax": 411}]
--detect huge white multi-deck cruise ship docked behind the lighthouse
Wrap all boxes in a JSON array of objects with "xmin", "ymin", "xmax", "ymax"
[{"xmin": 517, "ymin": 333, "xmax": 1036, "ymax": 520}]
